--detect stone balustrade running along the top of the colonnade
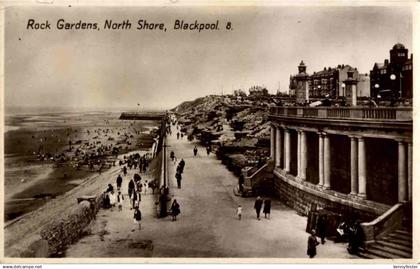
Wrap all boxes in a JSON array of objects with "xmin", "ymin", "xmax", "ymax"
[{"xmin": 270, "ymin": 106, "xmax": 413, "ymax": 121}]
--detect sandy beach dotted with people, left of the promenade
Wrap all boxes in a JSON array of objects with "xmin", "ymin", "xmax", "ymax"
[{"xmin": 4, "ymin": 112, "xmax": 158, "ymax": 222}]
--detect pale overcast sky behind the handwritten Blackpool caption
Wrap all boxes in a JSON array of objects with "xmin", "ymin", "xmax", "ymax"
[{"xmin": 5, "ymin": 6, "xmax": 412, "ymax": 109}]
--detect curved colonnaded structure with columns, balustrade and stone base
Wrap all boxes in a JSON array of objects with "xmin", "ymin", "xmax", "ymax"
[{"xmin": 269, "ymin": 107, "xmax": 413, "ymax": 221}]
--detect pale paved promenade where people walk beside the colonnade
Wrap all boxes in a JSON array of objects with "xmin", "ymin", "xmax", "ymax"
[{"xmin": 66, "ymin": 124, "xmax": 355, "ymax": 259}]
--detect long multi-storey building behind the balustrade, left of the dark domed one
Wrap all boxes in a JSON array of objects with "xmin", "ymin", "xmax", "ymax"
[{"xmin": 289, "ymin": 61, "xmax": 370, "ymax": 103}]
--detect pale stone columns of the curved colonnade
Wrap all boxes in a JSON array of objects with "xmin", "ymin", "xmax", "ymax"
[{"xmin": 270, "ymin": 125, "xmax": 413, "ymax": 202}]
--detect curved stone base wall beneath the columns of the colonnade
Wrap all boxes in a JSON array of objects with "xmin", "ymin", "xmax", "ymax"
[{"xmin": 273, "ymin": 171, "xmax": 386, "ymax": 221}]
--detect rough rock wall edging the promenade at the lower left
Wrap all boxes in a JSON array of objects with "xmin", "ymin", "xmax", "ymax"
[{"xmin": 36, "ymin": 194, "xmax": 103, "ymax": 254}]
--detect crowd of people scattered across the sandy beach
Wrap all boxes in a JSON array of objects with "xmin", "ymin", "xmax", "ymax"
[{"xmin": 25, "ymin": 121, "xmax": 158, "ymax": 175}]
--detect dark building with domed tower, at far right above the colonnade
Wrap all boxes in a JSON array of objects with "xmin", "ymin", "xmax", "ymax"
[{"xmin": 370, "ymin": 43, "xmax": 413, "ymax": 99}]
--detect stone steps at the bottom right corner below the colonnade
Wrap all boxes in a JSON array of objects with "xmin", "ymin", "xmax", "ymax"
[{"xmin": 359, "ymin": 228, "xmax": 413, "ymax": 259}]
